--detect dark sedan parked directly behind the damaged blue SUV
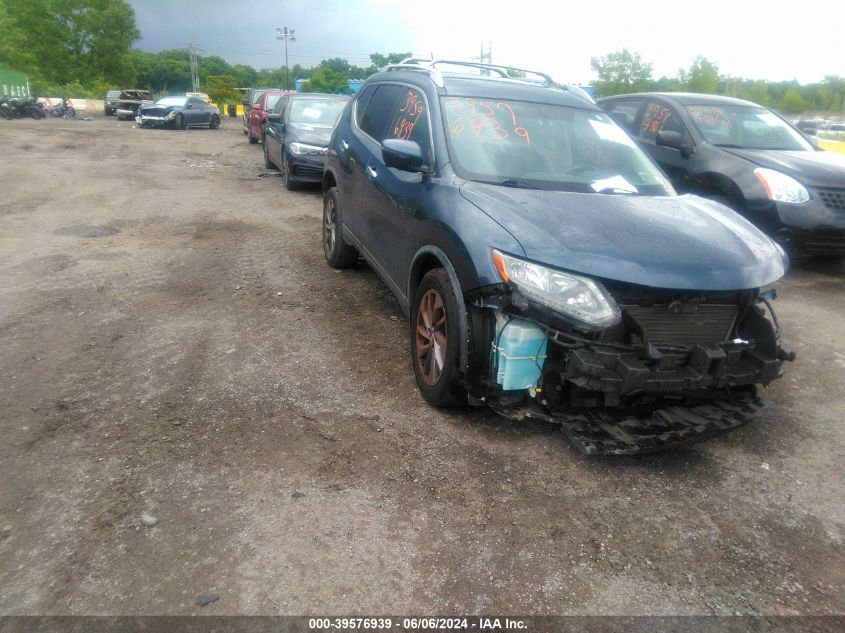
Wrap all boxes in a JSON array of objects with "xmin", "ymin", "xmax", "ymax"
[{"xmin": 264, "ymin": 93, "xmax": 349, "ymax": 189}]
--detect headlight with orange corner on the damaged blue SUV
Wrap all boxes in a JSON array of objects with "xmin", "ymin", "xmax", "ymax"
[{"xmin": 493, "ymin": 251, "xmax": 622, "ymax": 328}]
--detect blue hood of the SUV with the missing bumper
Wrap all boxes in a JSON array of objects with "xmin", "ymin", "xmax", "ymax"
[{"xmin": 461, "ymin": 182, "xmax": 788, "ymax": 290}]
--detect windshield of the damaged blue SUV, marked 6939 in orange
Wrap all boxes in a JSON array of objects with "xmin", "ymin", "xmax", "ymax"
[{"xmin": 442, "ymin": 97, "xmax": 674, "ymax": 196}]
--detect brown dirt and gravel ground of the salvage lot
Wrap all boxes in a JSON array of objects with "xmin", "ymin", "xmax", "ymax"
[{"xmin": 0, "ymin": 117, "xmax": 845, "ymax": 615}]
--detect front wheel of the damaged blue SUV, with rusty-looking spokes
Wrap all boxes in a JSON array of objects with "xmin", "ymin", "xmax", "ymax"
[{"xmin": 410, "ymin": 268, "xmax": 466, "ymax": 407}]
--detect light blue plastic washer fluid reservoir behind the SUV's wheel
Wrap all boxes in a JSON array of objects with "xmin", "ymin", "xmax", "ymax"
[{"xmin": 493, "ymin": 312, "xmax": 549, "ymax": 396}]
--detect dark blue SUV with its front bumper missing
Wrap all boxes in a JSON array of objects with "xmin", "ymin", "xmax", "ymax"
[{"xmin": 323, "ymin": 60, "xmax": 793, "ymax": 453}]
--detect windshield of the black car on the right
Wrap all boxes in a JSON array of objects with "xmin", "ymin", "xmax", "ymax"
[{"xmin": 686, "ymin": 105, "xmax": 813, "ymax": 152}]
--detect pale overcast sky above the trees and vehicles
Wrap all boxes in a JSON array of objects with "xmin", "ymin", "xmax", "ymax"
[{"xmin": 129, "ymin": 0, "xmax": 845, "ymax": 83}]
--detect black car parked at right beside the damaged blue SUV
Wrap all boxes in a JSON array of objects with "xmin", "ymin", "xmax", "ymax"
[{"xmin": 599, "ymin": 93, "xmax": 845, "ymax": 257}]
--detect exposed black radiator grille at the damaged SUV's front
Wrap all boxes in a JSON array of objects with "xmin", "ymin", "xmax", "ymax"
[{"xmin": 623, "ymin": 304, "xmax": 737, "ymax": 347}]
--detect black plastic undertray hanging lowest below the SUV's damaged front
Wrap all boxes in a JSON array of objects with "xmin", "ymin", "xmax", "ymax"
[{"xmin": 554, "ymin": 397, "xmax": 771, "ymax": 455}]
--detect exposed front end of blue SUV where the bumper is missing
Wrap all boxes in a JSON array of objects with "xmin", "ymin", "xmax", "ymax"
[{"xmin": 466, "ymin": 282, "xmax": 795, "ymax": 454}]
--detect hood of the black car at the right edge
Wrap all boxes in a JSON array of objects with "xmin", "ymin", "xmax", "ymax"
[{"xmin": 720, "ymin": 147, "xmax": 845, "ymax": 189}]
